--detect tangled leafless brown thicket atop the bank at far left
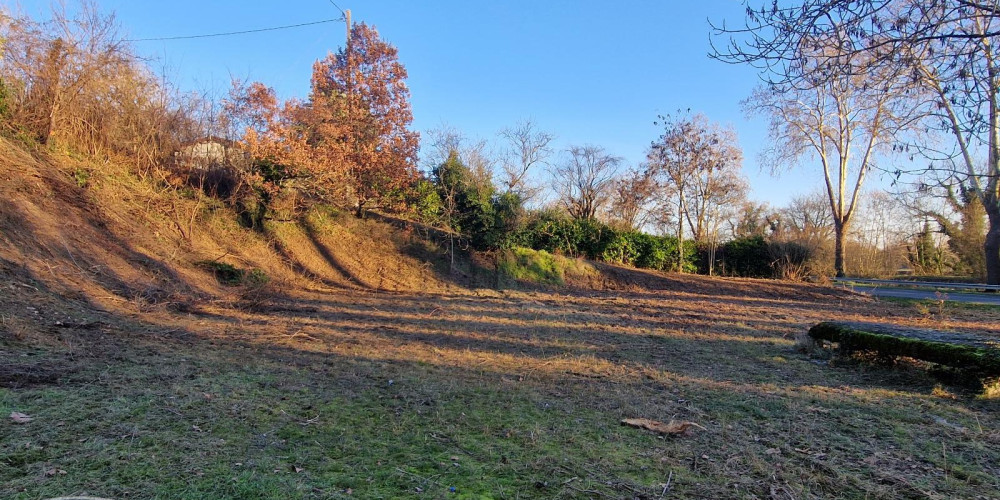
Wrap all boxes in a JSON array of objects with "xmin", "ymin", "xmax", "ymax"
[{"xmin": 0, "ymin": 2, "xmax": 201, "ymax": 175}]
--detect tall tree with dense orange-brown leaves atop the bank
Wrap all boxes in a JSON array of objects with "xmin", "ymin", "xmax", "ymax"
[{"xmin": 308, "ymin": 23, "xmax": 419, "ymax": 217}]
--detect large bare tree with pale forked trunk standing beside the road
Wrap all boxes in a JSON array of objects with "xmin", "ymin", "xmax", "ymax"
[{"xmin": 744, "ymin": 46, "xmax": 919, "ymax": 276}]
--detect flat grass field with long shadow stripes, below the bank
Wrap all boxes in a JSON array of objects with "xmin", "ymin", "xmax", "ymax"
[{"xmin": 0, "ymin": 277, "xmax": 1000, "ymax": 499}]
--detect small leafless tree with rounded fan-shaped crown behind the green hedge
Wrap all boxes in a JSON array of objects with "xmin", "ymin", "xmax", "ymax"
[{"xmin": 552, "ymin": 146, "xmax": 621, "ymax": 219}]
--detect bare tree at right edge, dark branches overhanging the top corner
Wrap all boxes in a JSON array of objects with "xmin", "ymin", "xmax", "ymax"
[{"xmin": 713, "ymin": 0, "xmax": 1000, "ymax": 284}]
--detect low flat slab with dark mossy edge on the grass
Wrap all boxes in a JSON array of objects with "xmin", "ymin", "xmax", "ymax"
[{"xmin": 809, "ymin": 321, "xmax": 1000, "ymax": 380}]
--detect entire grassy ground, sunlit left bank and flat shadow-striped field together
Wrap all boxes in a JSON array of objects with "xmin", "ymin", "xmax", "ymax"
[{"xmin": 0, "ymin": 138, "xmax": 1000, "ymax": 498}]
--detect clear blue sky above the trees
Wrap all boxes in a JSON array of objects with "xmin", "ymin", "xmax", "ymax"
[{"xmin": 22, "ymin": 0, "xmax": 904, "ymax": 206}]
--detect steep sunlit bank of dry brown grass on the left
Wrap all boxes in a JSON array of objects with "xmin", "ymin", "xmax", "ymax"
[{"xmin": 0, "ymin": 140, "xmax": 480, "ymax": 306}]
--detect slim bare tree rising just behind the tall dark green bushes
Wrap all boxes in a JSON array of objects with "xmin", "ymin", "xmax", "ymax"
[{"xmin": 500, "ymin": 119, "xmax": 555, "ymax": 201}]
